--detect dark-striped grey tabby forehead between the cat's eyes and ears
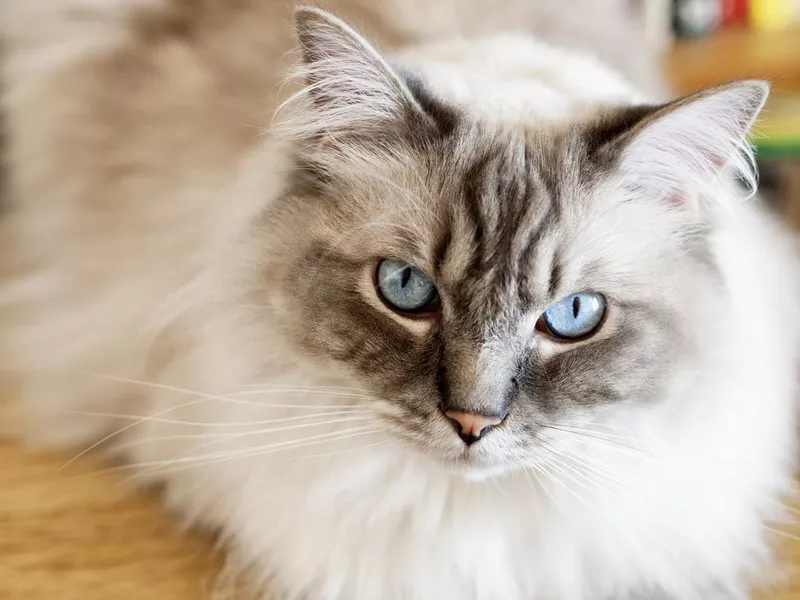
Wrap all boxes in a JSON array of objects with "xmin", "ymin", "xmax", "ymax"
[{"xmin": 436, "ymin": 127, "xmax": 570, "ymax": 316}]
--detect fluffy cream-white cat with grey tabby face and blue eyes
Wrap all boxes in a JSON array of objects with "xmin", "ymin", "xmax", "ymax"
[{"xmin": 0, "ymin": 0, "xmax": 800, "ymax": 600}]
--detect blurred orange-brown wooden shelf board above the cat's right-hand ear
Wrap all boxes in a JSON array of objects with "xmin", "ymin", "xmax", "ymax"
[{"xmin": 665, "ymin": 28, "xmax": 800, "ymax": 92}]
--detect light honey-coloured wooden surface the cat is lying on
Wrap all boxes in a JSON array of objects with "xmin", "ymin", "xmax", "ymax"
[{"xmin": 0, "ymin": 444, "xmax": 800, "ymax": 600}]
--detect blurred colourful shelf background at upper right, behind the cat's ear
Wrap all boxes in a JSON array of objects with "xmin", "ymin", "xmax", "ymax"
[{"xmin": 631, "ymin": 0, "xmax": 800, "ymax": 229}]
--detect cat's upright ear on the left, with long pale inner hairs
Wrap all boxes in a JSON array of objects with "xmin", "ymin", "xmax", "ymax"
[{"xmin": 284, "ymin": 8, "xmax": 438, "ymax": 149}]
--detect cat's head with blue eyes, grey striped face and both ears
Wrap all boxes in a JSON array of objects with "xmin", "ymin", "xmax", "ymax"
[{"xmin": 260, "ymin": 9, "xmax": 767, "ymax": 470}]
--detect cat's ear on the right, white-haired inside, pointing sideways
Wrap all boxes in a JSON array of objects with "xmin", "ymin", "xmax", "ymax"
[{"xmin": 611, "ymin": 81, "xmax": 769, "ymax": 205}]
